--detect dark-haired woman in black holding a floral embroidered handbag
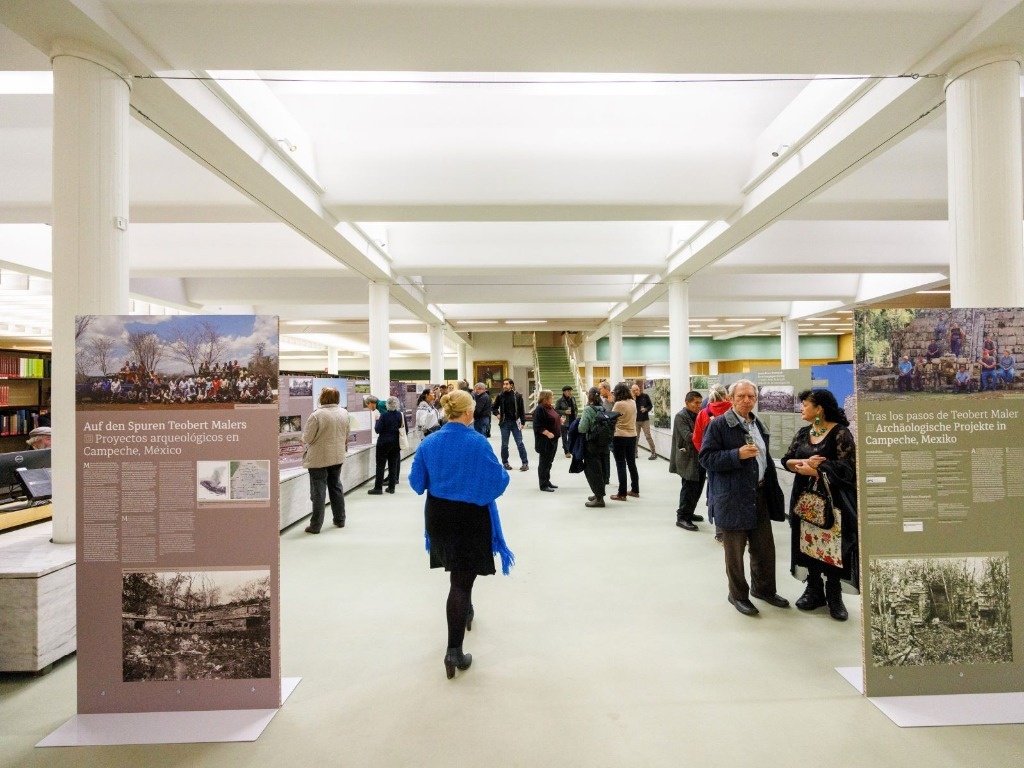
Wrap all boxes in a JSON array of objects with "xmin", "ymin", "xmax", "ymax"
[{"xmin": 781, "ymin": 389, "xmax": 859, "ymax": 622}]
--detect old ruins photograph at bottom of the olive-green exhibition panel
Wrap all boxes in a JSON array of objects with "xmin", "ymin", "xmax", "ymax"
[{"xmin": 868, "ymin": 553, "xmax": 1014, "ymax": 667}]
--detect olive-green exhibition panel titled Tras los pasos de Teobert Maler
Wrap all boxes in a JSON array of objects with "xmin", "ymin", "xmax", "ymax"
[{"xmin": 854, "ymin": 308, "xmax": 1024, "ymax": 696}]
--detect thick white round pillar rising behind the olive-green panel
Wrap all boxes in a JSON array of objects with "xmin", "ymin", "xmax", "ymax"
[{"xmin": 946, "ymin": 51, "xmax": 1024, "ymax": 307}]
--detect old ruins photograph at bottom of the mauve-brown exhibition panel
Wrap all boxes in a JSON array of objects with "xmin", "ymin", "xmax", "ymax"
[{"xmin": 121, "ymin": 569, "xmax": 271, "ymax": 683}]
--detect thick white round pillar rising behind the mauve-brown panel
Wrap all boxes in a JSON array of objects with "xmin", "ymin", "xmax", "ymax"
[{"xmin": 51, "ymin": 43, "xmax": 130, "ymax": 544}]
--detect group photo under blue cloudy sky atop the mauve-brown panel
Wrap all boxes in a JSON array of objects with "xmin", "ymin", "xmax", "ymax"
[{"xmin": 75, "ymin": 314, "xmax": 279, "ymax": 411}]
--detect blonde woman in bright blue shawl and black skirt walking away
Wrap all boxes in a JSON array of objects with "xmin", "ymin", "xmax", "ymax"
[{"xmin": 409, "ymin": 389, "xmax": 515, "ymax": 680}]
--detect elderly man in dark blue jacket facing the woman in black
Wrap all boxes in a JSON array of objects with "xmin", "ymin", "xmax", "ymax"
[{"xmin": 698, "ymin": 379, "xmax": 790, "ymax": 616}]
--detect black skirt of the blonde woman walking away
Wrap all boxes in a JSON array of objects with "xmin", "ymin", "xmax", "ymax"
[{"xmin": 425, "ymin": 494, "xmax": 495, "ymax": 575}]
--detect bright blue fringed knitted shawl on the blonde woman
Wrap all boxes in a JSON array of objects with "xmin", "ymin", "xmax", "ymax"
[{"xmin": 409, "ymin": 422, "xmax": 515, "ymax": 575}]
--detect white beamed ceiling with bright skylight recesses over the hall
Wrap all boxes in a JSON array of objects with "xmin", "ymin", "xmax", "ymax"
[{"xmin": 0, "ymin": 0, "xmax": 1024, "ymax": 362}]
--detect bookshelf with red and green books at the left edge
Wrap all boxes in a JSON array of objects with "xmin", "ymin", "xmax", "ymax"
[{"xmin": 0, "ymin": 349, "xmax": 50, "ymax": 453}]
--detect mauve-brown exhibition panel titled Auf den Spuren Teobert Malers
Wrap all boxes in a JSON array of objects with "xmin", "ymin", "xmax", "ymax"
[{"xmin": 75, "ymin": 315, "xmax": 281, "ymax": 714}]
